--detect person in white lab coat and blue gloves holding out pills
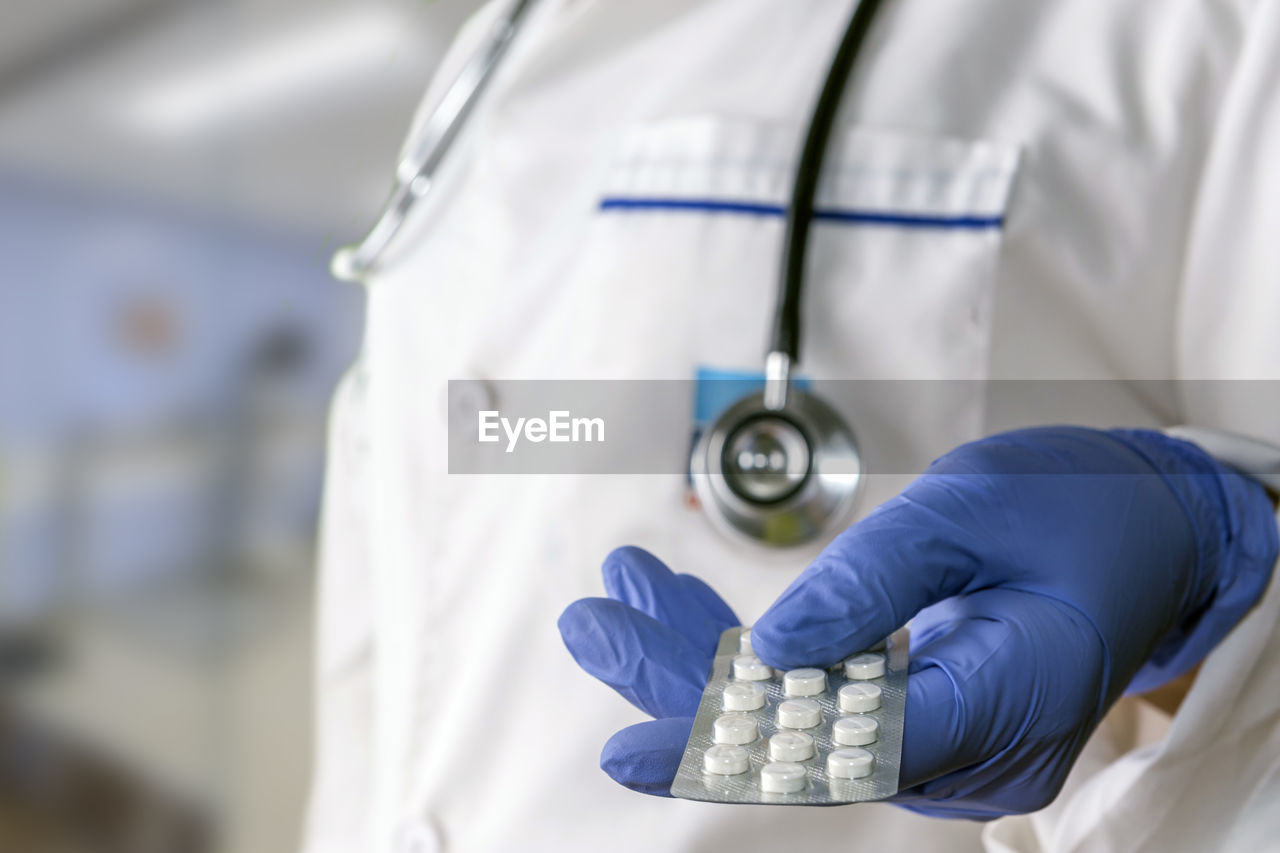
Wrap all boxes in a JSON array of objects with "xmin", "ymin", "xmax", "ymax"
[{"xmin": 306, "ymin": 0, "xmax": 1280, "ymax": 853}]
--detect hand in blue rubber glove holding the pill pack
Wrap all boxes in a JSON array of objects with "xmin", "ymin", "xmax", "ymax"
[{"xmin": 561, "ymin": 428, "xmax": 1277, "ymax": 818}]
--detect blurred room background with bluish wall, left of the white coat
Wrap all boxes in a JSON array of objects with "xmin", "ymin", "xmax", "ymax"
[{"xmin": 0, "ymin": 0, "xmax": 479, "ymax": 853}]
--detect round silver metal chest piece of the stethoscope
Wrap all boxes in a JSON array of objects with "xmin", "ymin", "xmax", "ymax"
[{"xmin": 689, "ymin": 388, "xmax": 863, "ymax": 548}]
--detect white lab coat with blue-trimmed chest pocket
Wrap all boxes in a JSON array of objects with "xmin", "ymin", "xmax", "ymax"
[{"xmin": 306, "ymin": 0, "xmax": 1280, "ymax": 853}]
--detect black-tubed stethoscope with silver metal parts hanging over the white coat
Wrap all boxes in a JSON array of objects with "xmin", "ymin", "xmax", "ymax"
[{"xmin": 333, "ymin": 0, "xmax": 881, "ymax": 547}]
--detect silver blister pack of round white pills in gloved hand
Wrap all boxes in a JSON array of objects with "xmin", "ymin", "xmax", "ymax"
[{"xmin": 671, "ymin": 628, "xmax": 909, "ymax": 806}]
